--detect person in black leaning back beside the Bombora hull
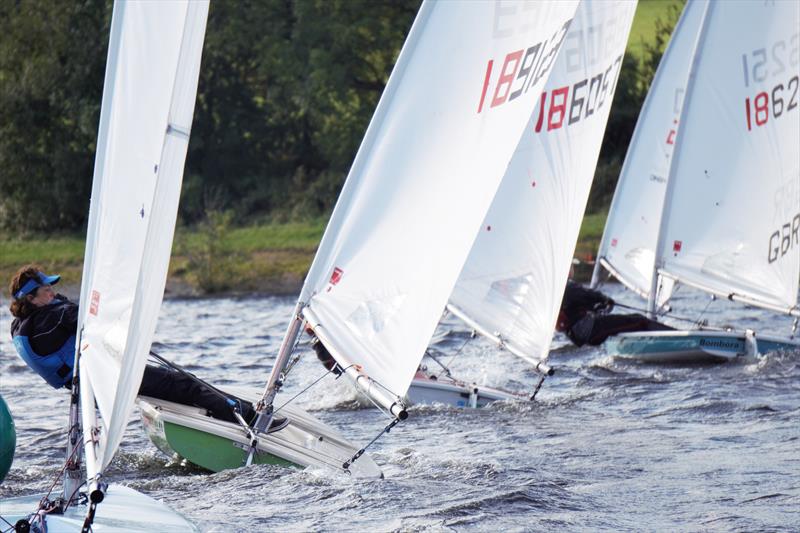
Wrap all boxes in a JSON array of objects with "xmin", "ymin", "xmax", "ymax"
[{"xmin": 556, "ymin": 267, "xmax": 675, "ymax": 346}]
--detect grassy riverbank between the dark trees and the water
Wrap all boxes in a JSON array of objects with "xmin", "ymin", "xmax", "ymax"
[{"xmin": 0, "ymin": 213, "xmax": 606, "ymax": 298}]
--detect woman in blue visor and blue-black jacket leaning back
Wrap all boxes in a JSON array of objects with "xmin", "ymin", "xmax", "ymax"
[{"xmin": 9, "ymin": 265, "xmax": 288, "ymax": 431}]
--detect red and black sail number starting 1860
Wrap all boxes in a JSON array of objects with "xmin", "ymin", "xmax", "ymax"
[{"xmin": 534, "ymin": 55, "xmax": 622, "ymax": 133}]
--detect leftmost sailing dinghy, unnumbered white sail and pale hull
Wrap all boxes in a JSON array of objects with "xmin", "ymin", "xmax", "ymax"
[{"xmin": 0, "ymin": 0, "xmax": 208, "ymax": 533}]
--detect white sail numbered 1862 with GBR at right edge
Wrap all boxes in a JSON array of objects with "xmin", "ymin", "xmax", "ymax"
[{"xmin": 657, "ymin": 0, "xmax": 800, "ymax": 315}]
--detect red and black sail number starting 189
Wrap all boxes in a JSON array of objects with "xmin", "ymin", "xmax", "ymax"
[{"xmin": 478, "ymin": 19, "xmax": 572, "ymax": 113}]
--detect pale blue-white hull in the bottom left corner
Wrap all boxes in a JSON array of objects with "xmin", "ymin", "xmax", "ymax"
[{"xmin": 0, "ymin": 485, "xmax": 198, "ymax": 533}]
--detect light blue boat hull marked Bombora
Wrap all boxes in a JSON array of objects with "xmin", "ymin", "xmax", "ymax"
[{"xmin": 606, "ymin": 330, "xmax": 800, "ymax": 363}]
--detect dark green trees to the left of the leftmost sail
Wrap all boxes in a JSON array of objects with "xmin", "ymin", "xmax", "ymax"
[{"xmin": 0, "ymin": 0, "xmax": 111, "ymax": 231}]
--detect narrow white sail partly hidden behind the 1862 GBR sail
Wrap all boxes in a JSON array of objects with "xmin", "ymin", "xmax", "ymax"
[{"xmin": 592, "ymin": 0, "xmax": 707, "ymax": 303}]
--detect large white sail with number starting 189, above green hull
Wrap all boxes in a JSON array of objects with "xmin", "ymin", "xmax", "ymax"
[{"xmin": 300, "ymin": 1, "xmax": 577, "ymax": 395}]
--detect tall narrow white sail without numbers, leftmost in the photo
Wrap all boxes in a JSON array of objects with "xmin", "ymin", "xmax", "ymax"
[{"xmin": 78, "ymin": 0, "xmax": 208, "ymax": 479}]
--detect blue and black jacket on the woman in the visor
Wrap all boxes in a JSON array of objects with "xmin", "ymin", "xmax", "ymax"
[{"xmin": 11, "ymin": 294, "xmax": 78, "ymax": 389}]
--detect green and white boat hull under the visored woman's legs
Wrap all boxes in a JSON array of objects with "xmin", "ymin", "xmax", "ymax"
[{"xmin": 139, "ymin": 391, "xmax": 383, "ymax": 478}]
